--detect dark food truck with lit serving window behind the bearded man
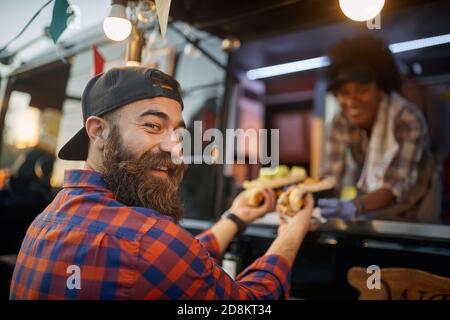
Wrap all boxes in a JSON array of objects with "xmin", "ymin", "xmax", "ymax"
[{"xmin": 0, "ymin": 0, "xmax": 450, "ymax": 300}]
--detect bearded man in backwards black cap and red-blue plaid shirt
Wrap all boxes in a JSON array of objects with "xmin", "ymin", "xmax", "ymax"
[{"xmin": 10, "ymin": 67, "xmax": 313, "ymax": 299}]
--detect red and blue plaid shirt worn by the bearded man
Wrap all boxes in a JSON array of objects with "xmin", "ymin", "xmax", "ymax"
[{"xmin": 10, "ymin": 170, "xmax": 290, "ymax": 299}]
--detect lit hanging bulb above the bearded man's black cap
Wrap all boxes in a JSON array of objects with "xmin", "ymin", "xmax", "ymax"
[{"xmin": 103, "ymin": 0, "xmax": 131, "ymax": 41}]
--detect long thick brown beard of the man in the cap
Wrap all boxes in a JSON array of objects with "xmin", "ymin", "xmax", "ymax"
[{"xmin": 102, "ymin": 126, "xmax": 186, "ymax": 223}]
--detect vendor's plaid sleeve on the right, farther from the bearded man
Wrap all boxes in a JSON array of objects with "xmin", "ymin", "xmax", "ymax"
[{"xmin": 383, "ymin": 109, "xmax": 425, "ymax": 202}]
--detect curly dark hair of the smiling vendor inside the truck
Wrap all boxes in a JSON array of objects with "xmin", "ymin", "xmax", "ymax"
[{"xmin": 326, "ymin": 35, "xmax": 402, "ymax": 93}]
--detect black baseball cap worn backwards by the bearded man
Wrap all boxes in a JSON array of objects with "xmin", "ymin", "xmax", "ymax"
[{"xmin": 58, "ymin": 67, "xmax": 183, "ymax": 161}]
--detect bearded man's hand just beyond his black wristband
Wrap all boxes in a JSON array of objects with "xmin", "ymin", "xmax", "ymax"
[{"xmin": 228, "ymin": 189, "xmax": 276, "ymax": 223}]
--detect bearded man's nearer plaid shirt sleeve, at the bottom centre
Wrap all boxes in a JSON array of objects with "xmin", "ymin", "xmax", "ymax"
[{"xmin": 131, "ymin": 221, "xmax": 290, "ymax": 300}]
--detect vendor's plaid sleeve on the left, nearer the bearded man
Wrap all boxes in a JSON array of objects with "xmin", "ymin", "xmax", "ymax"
[{"xmin": 325, "ymin": 114, "xmax": 348, "ymax": 182}]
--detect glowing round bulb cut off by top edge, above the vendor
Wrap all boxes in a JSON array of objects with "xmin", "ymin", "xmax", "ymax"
[{"xmin": 339, "ymin": 0, "xmax": 385, "ymax": 21}]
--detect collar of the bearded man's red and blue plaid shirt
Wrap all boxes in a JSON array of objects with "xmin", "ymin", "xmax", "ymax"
[{"xmin": 63, "ymin": 169, "xmax": 111, "ymax": 192}]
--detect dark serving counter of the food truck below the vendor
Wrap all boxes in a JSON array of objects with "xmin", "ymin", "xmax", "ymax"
[{"xmin": 182, "ymin": 213, "xmax": 450, "ymax": 299}]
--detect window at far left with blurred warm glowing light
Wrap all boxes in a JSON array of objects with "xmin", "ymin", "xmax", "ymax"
[{"xmin": 0, "ymin": 60, "xmax": 71, "ymax": 196}]
